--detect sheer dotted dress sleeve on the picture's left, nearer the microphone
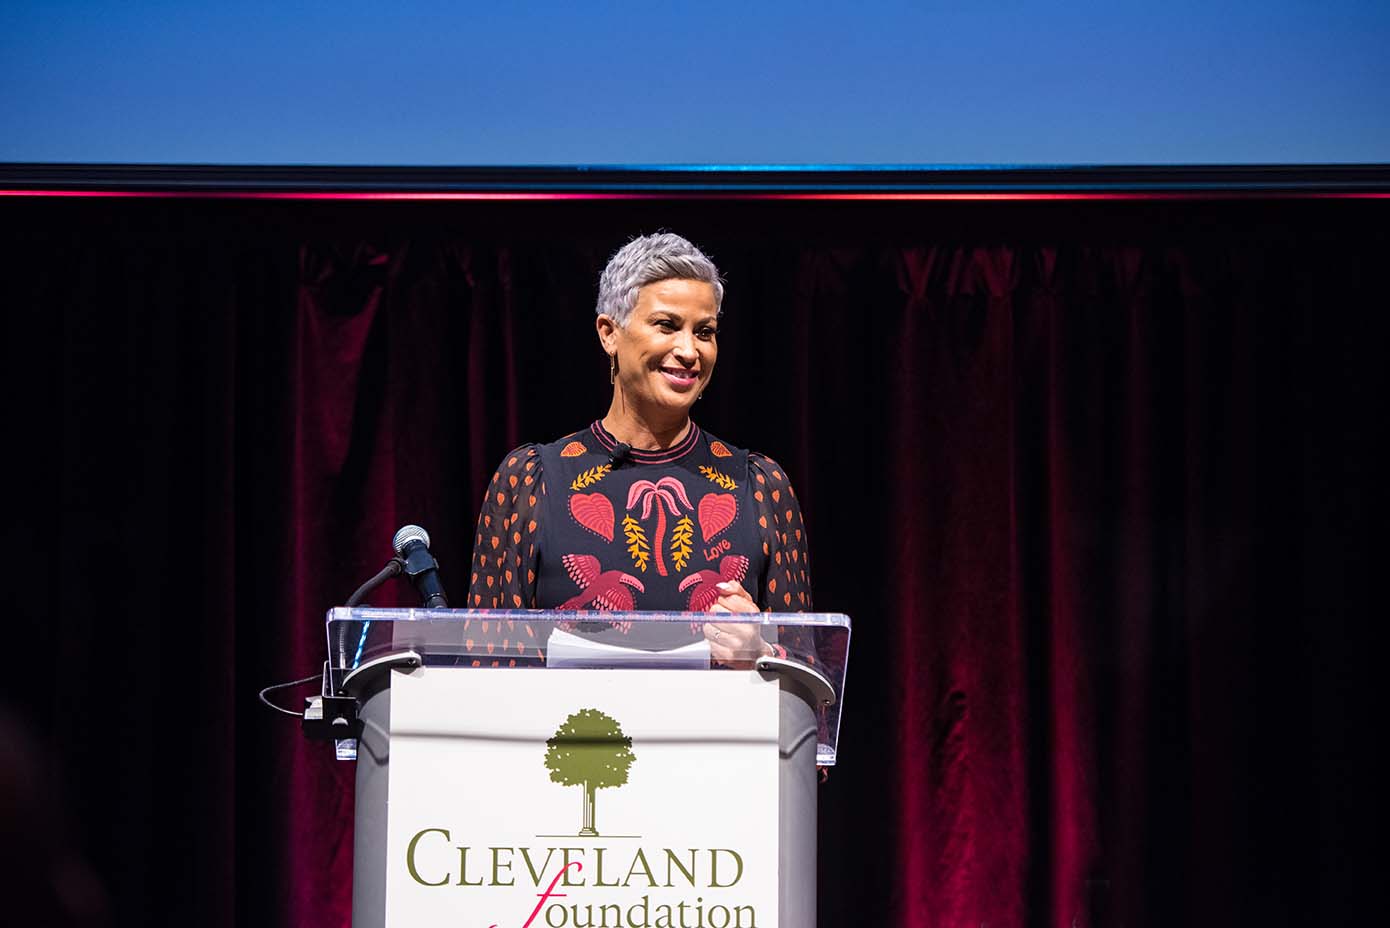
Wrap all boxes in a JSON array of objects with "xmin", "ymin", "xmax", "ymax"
[{"xmin": 468, "ymin": 445, "xmax": 542, "ymax": 608}]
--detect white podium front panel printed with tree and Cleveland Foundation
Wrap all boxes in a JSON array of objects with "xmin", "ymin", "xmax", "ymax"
[{"xmin": 385, "ymin": 667, "xmax": 780, "ymax": 928}]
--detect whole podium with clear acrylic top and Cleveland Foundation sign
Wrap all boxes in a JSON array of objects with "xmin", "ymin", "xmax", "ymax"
[{"xmin": 306, "ymin": 608, "xmax": 849, "ymax": 928}]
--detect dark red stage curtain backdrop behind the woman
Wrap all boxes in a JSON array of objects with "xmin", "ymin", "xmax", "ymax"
[{"xmin": 0, "ymin": 199, "xmax": 1390, "ymax": 928}]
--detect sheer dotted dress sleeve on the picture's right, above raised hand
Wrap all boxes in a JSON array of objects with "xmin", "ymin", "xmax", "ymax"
[{"xmin": 748, "ymin": 453, "xmax": 812, "ymax": 613}]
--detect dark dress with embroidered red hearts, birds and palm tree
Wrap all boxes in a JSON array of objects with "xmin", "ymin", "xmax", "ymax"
[{"xmin": 467, "ymin": 422, "xmax": 812, "ymax": 658}]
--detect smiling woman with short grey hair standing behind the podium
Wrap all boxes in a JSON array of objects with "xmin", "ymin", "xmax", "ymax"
[{"xmin": 467, "ymin": 233, "xmax": 812, "ymax": 663}]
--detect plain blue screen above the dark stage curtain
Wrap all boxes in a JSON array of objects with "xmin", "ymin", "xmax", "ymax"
[{"xmin": 0, "ymin": 0, "xmax": 1390, "ymax": 164}]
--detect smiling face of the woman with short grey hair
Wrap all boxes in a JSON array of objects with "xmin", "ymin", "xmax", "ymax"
[{"xmin": 598, "ymin": 279, "xmax": 719, "ymax": 414}]
